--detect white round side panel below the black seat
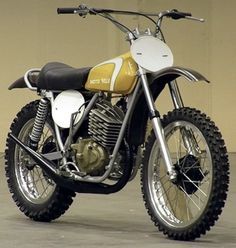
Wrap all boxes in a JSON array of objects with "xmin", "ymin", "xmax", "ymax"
[{"xmin": 52, "ymin": 90, "xmax": 85, "ymax": 128}]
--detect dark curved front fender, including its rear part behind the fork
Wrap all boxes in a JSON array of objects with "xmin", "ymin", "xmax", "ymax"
[{"xmin": 127, "ymin": 66, "xmax": 209, "ymax": 146}]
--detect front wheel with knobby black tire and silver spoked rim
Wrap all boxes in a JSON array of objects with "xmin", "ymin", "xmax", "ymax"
[{"xmin": 141, "ymin": 108, "xmax": 229, "ymax": 240}]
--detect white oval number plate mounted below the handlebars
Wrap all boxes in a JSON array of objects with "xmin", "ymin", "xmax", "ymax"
[{"xmin": 130, "ymin": 36, "xmax": 174, "ymax": 72}]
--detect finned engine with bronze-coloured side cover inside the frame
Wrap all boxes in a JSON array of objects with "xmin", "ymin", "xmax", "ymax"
[{"xmin": 71, "ymin": 100, "xmax": 124, "ymax": 176}]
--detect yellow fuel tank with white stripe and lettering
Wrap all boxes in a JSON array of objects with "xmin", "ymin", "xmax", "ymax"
[{"xmin": 85, "ymin": 53, "xmax": 138, "ymax": 95}]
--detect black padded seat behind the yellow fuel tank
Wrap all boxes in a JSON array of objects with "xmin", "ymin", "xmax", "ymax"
[{"xmin": 38, "ymin": 62, "xmax": 91, "ymax": 90}]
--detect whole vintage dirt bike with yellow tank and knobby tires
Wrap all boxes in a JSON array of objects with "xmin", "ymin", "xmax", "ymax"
[{"xmin": 5, "ymin": 5, "xmax": 229, "ymax": 240}]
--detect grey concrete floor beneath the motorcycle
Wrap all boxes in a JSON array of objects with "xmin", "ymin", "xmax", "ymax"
[{"xmin": 0, "ymin": 154, "xmax": 236, "ymax": 248}]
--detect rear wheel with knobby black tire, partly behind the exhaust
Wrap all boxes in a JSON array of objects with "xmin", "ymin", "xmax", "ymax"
[{"xmin": 5, "ymin": 101, "xmax": 75, "ymax": 222}]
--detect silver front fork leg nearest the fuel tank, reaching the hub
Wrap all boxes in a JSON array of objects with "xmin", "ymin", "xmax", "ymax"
[{"xmin": 139, "ymin": 67, "xmax": 176, "ymax": 181}]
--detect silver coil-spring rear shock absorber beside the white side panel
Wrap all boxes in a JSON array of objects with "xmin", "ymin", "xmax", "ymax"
[{"xmin": 29, "ymin": 98, "xmax": 49, "ymax": 151}]
